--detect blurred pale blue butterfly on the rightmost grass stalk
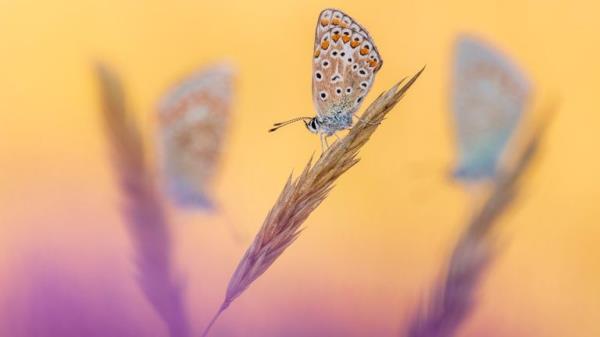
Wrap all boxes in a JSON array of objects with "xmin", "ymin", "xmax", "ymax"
[{"xmin": 451, "ymin": 36, "xmax": 531, "ymax": 181}]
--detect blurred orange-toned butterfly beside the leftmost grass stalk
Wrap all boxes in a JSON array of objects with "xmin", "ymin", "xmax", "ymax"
[{"xmin": 158, "ymin": 64, "xmax": 233, "ymax": 209}]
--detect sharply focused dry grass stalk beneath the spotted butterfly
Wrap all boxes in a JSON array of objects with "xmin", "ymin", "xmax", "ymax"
[{"xmin": 203, "ymin": 68, "xmax": 424, "ymax": 336}]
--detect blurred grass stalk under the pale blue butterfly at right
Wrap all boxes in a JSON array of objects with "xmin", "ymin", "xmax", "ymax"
[{"xmin": 406, "ymin": 104, "xmax": 553, "ymax": 337}]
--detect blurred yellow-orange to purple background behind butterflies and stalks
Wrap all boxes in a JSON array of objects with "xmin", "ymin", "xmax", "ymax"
[{"xmin": 0, "ymin": 0, "xmax": 600, "ymax": 337}]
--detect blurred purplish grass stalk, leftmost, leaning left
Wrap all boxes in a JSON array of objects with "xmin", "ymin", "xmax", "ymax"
[{"xmin": 96, "ymin": 65, "xmax": 189, "ymax": 337}]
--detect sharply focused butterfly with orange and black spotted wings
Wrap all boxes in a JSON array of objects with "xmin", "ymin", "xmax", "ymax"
[{"xmin": 269, "ymin": 9, "xmax": 383, "ymax": 148}]
